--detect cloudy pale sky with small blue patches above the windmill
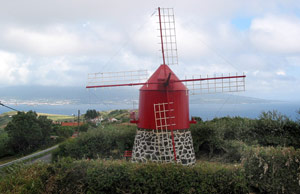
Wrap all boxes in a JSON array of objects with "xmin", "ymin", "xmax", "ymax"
[{"xmin": 0, "ymin": 0, "xmax": 300, "ymax": 101}]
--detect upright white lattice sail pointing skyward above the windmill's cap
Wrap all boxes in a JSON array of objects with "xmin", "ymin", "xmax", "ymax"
[{"xmin": 157, "ymin": 8, "xmax": 178, "ymax": 65}]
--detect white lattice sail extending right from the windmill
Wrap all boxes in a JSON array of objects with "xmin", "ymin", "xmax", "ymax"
[{"xmin": 185, "ymin": 73, "xmax": 245, "ymax": 95}]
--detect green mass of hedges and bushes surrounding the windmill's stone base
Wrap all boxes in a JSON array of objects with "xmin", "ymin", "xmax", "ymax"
[{"xmin": 0, "ymin": 110, "xmax": 300, "ymax": 194}]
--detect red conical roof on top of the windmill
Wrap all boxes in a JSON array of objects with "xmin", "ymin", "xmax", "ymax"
[{"xmin": 140, "ymin": 65, "xmax": 187, "ymax": 91}]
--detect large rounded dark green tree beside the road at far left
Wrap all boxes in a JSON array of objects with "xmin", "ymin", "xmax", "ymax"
[{"xmin": 5, "ymin": 111, "xmax": 52, "ymax": 153}]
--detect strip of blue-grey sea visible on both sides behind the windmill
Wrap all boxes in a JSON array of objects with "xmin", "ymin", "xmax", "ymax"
[{"xmin": 0, "ymin": 102, "xmax": 300, "ymax": 120}]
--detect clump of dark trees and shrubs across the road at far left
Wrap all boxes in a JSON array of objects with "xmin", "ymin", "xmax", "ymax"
[{"xmin": 0, "ymin": 111, "xmax": 73, "ymax": 158}]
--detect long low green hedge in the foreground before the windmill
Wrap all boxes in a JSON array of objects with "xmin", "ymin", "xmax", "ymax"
[{"xmin": 0, "ymin": 159, "xmax": 248, "ymax": 194}]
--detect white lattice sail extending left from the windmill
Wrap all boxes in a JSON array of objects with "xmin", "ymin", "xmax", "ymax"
[{"xmin": 88, "ymin": 70, "xmax": 148, "ymax": 87}]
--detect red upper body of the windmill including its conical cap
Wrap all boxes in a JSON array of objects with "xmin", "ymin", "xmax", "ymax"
[{"xmin": 138, "ymin": 65, "xmax": 189, "ymax": 130}]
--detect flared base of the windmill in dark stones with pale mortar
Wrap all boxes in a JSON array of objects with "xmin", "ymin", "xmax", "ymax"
[{"xmin": 132, "ymin": 129, "xmax": 196, "ymax": 165}]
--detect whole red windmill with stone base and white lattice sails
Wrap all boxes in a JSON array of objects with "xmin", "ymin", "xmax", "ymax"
[{"xmin": 86, "ymin": 8, "xmax": 246, "ymax": 165}]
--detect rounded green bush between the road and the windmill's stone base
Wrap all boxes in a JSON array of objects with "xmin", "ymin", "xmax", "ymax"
[{"xmin": 53, "ymin": 125, "xmax": 136, "ymax": 160}]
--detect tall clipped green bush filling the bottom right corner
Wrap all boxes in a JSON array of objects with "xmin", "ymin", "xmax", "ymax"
[{"xmin": 243, "ymin": 147, "xmax": 300, "ymax": 194}]
